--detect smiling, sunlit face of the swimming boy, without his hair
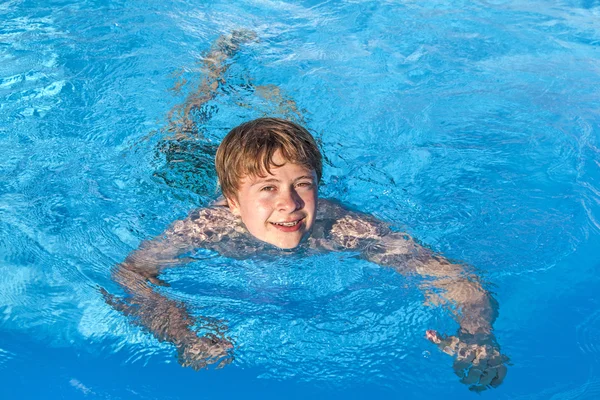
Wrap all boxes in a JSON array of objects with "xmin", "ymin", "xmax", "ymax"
[{"xmin": 227, "ymin": 152, "xmax": 317, "ymax": 249}]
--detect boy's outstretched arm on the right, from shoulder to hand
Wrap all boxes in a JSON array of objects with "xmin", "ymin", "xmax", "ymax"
[{"xmin": 331, "ymin": 211, "xmax": 507, "ymax": 390}]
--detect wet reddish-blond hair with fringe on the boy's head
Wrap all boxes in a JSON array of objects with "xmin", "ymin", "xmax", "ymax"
[{"xmin": 215, "ymin": 118, "xmax": 323, "ymax": 199}]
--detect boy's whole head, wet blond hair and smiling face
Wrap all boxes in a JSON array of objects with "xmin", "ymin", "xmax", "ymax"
[{"xmin": 216, "ymin": 118, "xmax": 322, "ymax": 248}]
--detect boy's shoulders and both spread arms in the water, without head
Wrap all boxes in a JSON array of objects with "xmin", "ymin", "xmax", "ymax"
[{"xmin": 112, "ymin": 181, "xmax": 506, "ymax": 390}]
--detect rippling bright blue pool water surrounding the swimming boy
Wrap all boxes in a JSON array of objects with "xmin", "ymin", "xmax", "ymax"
[{"xmin": 0, "ymin": 0, "xmax": 600, "ymax": 399}]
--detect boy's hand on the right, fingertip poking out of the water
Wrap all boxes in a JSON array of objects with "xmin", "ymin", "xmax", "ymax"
[{"xmin": 425, "ymin": 330, "xmax": 508, "ymax": 392}]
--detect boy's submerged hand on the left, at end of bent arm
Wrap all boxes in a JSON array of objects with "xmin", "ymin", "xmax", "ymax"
[{"xmin": 177, "ymin": 335, "xmax": 233, "ymax": 371}]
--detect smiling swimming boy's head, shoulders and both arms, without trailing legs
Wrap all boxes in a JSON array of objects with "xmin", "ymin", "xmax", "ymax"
[{"xmin": 106, "ymin": 118, "xmax": 506, "ymax": 390}]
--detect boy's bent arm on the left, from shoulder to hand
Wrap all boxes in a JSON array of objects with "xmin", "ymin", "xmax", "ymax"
[{"xmin": 103, "ymin": 208, "xmax": 233, "ymax": 369}]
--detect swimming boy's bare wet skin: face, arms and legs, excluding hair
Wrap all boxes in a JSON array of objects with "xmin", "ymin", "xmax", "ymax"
[{"xmin": 108, "ymin": 31, "xmax": 506, "ymax": 391}]
